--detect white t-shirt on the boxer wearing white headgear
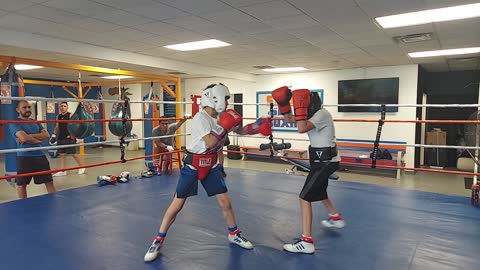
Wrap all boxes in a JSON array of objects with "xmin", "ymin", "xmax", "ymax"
[{"xmin": 187, "ymin": 110, "xmax": 225, "ymax": 154}]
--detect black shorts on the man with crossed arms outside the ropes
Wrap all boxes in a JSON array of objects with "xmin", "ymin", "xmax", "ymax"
[{"xmin": 17, "ymin": 156, "xmax": 53, "ymax": 186}]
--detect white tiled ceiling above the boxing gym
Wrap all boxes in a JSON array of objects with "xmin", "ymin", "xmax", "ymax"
[{"xmin": 0, "ymin": 0, "xmax": 480, "ymax": 80}]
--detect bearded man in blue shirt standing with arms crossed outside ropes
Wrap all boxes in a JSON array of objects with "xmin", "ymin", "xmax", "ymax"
[{"xmin": 9, "ymin": 100, "xmax": 56, "ymax": 199}]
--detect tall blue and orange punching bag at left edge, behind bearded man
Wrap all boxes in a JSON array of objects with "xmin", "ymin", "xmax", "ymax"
[{"xmin": 0, "ymin": 64, "xmax": 25, "ymax": 183}]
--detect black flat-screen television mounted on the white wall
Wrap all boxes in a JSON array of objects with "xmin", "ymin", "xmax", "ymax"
[{"xmin": 338, "ymin": 78, "xmax": 399, "ymax": 112}]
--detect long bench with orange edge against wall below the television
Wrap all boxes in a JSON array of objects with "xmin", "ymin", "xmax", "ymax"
[{"xmin": 337, "ymin": 139, "xmax": 407, "ymax": 179}]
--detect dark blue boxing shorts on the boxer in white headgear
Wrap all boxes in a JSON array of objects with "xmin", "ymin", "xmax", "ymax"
[{"xmin": 176, "ymin": 163, "xmax": 228, "ymax": 199}]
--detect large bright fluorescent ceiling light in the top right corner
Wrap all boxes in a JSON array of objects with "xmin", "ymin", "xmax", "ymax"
[{"xmin": 375, "ymin": 3, "xmax": 480, "ymax": 28}]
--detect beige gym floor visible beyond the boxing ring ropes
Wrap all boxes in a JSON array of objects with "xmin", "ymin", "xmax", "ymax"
[{"xmin": 0, "ymin": 147, "xmax": 471, "ymax": 202}]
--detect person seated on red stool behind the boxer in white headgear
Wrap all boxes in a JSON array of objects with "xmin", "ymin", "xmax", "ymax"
[{"xmin": 152, "ymin": 115, "xmax": 189, "ymax": 173}]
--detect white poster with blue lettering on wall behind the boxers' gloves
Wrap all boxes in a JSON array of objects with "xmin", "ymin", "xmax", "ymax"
[{"xmin": 257, "ymin": 89, "xmax": 323, "ymax": 132}]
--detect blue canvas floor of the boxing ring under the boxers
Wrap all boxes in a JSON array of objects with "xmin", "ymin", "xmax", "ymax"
[{"xmin": 0, "ymin": 169, "xmax": 480, "ymax": 270}]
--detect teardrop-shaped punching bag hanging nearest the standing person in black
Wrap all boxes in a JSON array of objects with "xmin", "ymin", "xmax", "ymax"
[{"xmin": 67, "ymin": 102, "xmax": 95, "ymax": 139}]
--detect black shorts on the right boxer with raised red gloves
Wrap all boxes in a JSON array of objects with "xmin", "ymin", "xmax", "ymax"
[{"xmin": 299, "ymin": 162, "xmax": 339, "ymax": 202}]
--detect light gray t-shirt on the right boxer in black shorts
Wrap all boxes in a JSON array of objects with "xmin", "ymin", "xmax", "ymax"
[{"xmin": 307, "ymin": 109, "xmax": 340, "ymax": 161}]
